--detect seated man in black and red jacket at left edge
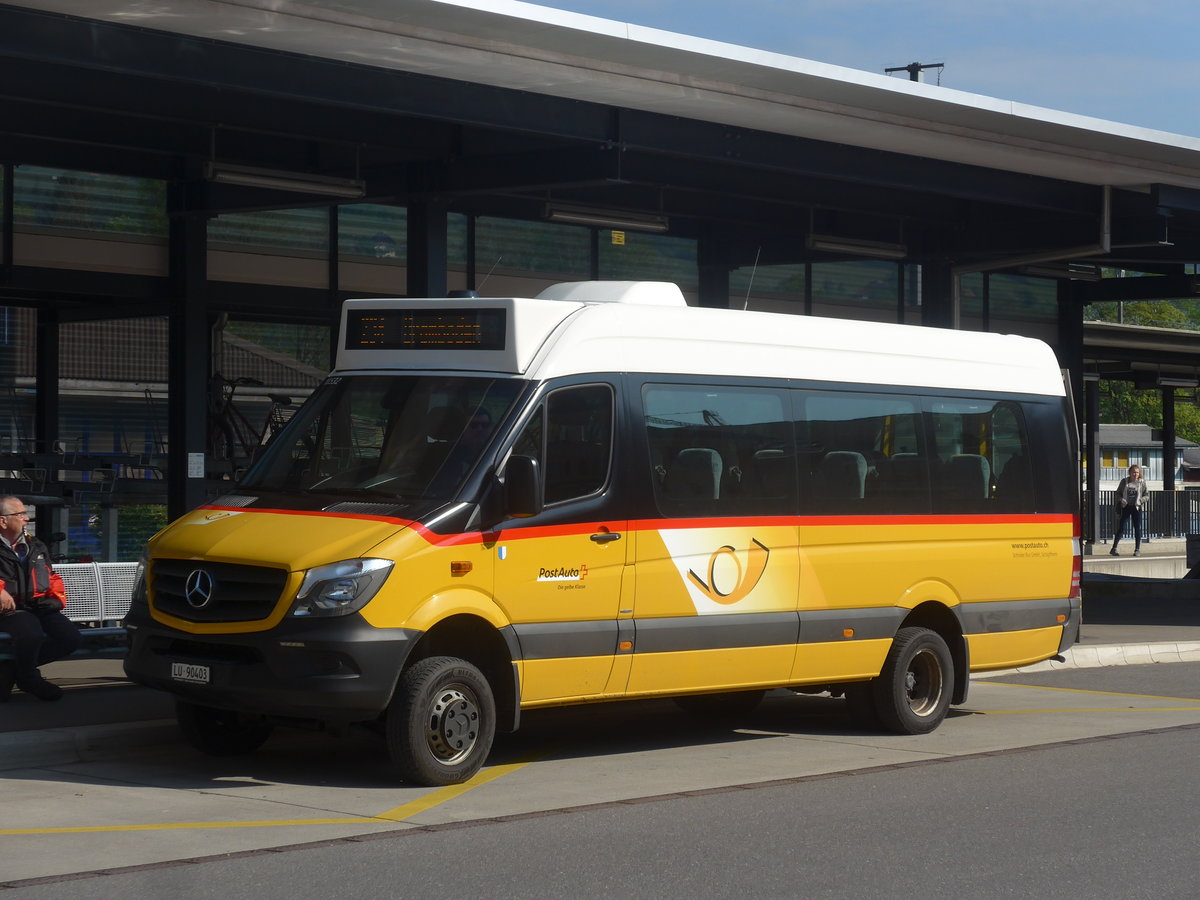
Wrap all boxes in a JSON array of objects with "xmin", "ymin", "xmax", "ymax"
[{"xmin": 0, "ymin": 497, "xmax": 79, "ymax": 702}]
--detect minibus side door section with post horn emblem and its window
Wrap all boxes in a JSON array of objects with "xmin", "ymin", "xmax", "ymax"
[{"xmin": 629, "ymin": 384, "xmax": 799, "ymax": 694}]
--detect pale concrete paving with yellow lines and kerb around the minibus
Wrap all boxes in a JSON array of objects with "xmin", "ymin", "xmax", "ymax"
[{"xmin": 0, "ymin": 556, "xmax": 1200, "ymax": 896}]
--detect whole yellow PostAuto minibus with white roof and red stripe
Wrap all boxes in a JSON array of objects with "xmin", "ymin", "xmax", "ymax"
[{"xmin": 125, "ymin": 282, "xmax": 1080, "ymax": 785}]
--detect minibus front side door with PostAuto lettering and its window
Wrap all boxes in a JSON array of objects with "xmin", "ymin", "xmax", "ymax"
[{"xmin": 494, "ymin": 383, "xmax": 630, "ymax": 703}]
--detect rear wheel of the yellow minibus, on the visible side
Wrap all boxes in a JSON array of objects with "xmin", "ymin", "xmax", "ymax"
[{"xmin": 872, "ymin": 628, "xmax": 954, "ymax": 734}]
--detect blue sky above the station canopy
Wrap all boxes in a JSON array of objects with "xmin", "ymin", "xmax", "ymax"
[{"xmin": 539, "ymin": 0, "xmax": 1200, "ymax": 137}]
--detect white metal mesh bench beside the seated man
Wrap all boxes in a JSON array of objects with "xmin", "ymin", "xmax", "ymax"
[{"xmin": 0, "ymin": 563, "xmax": 138, "ymax": 659}]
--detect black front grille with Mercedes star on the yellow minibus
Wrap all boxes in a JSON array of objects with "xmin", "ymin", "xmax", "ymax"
[{"xmin": 149, "ymin": 559, "xmax": 288, "ymax": 622}]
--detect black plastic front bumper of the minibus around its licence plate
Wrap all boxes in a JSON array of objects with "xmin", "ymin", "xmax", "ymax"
[{"xmin": 125, "ymin": 607, "xmax": 421, "ymax": 724}]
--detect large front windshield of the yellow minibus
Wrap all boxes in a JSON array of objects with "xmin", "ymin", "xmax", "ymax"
[{"xmin": 241, "ymin": 374, "xmax": 523, "ymax": 502}]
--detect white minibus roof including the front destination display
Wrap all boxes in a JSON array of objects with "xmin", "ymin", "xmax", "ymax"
[{"xmin": 337, "ymin": 282, "xmax": 1064, "ymax": 396}]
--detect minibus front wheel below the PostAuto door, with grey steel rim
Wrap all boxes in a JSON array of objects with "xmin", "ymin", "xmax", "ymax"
[{"xmin": 384, "ymin": 656, "xmax": 496, "ymax": 787}]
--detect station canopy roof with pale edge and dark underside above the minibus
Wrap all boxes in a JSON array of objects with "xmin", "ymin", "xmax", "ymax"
[{"xmin": 7, "ymin": 0, "xmax": 1200, "ymax": 309}]
